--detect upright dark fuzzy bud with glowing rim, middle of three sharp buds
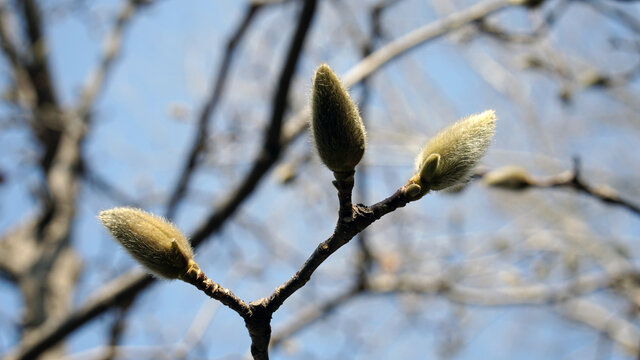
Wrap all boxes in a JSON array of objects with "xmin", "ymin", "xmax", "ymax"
[{"xmin": 311, "ymin": 64, "xmax": 366, "ymax": 173}]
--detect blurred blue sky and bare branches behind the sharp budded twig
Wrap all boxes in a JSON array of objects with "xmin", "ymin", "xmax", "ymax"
[{"xmin": 0, "ymin": 0, "xmax": 640, "ymax": 360}]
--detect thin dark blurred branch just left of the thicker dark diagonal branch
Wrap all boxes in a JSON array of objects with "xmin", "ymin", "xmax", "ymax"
[{"xmin": 166, "ymin": 2, "xmax": 265, "ymax": 219}]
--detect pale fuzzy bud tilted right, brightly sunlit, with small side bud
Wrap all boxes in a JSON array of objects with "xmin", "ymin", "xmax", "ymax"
[{"xmin": 409, "ymin": 110, "xmax": 496, "ymax": 196}]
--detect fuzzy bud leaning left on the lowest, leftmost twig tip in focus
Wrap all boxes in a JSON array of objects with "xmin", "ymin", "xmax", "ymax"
[{"xmin": 98, "ymin": 207, "xmax": 194, "ymax": 279}]
